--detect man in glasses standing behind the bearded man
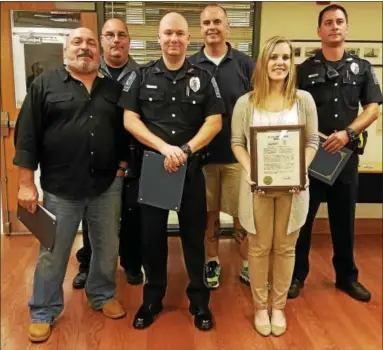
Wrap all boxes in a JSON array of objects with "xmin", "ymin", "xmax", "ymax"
[{"xmin": 73, "ymin": 18, "xmax": 143, "ymax": 288}]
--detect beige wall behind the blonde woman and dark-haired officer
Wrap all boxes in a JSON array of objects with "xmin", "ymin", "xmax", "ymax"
[{"xmin": 260, "ymin": 1, "xmax": 383, "ymax": 218}]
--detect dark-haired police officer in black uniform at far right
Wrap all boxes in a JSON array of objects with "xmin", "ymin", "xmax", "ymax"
[{"xmin": 289, "ymin": 4, "xmax": 382, "ymax": 301}]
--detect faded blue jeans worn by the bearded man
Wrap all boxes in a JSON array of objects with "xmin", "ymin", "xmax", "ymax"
[{"xmin": 29, "ymin": 177, "xmax": 123, "ymax": 324}]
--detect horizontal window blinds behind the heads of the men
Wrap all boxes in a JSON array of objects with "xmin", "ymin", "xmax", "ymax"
[{"xmin": 104, "ymin": 1, "xmax": 255, "ymax": 64}]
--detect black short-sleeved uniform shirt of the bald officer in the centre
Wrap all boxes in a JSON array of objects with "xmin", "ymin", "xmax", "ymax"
[{"xmin": 118, "ymin": 59, "xmax": 224, "ymax": 146}]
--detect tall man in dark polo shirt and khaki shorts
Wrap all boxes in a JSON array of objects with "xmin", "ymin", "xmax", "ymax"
[{"xmin": 190, "ymin": 4, "xmax": 254, "ymax": 288}]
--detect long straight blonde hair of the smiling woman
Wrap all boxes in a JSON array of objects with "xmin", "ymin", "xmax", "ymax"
[{"xmin": 250, "ymin": 36, "xmax": 297, "ymax": 109}]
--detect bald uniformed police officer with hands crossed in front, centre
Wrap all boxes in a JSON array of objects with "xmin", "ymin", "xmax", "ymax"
[{"xmin": 119, "ymin": 13, "xmax": 224, "ymax": 330}]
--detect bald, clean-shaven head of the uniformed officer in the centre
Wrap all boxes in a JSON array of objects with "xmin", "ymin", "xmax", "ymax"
[{"xmin": 158, "ymin": 12, "xmax": 190, "ymax": 58}]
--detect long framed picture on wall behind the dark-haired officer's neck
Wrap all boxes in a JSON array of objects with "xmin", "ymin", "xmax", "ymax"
[{"xmin": 291, "ymin": 40, "xmax": 383, "ymax": 67}]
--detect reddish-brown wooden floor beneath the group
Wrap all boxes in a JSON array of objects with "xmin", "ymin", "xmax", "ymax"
[{"xmin": 1, "ymin": 235, "xmax": 382, "ymax": 350}]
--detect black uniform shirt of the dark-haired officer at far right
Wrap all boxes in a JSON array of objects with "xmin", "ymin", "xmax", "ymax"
[{"xmin": 298, "ymin": 51, "xmax": 383, "ymax": 135}]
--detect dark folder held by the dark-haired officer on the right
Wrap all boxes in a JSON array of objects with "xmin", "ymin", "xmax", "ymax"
[{"xmin": 309, "ymin": 137, "xmax": 352, "ymax": 186}]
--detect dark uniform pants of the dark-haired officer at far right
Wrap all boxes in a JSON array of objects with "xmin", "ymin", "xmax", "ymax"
[{"xmin": 293, "ymin": 155, "xmax": 358, "ymax": 282}]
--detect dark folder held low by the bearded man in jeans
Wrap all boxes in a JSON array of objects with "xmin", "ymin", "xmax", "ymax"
[{"xmin": 17, "ymin": 205, "xmax": 56, "ymax": 251}]
